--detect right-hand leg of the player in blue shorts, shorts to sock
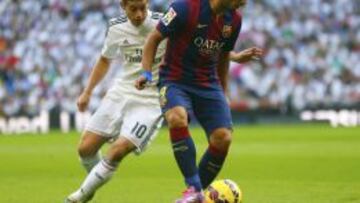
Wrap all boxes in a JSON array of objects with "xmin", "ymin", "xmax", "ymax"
[{"xmin": 194, "ymin": 93, "xmax": 232, "ymax": 188}]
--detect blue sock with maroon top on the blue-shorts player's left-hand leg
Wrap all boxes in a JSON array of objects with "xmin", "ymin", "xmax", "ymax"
[{"xmin": 170, "ymin": 127, "xmax": 202, "ymax": 191}]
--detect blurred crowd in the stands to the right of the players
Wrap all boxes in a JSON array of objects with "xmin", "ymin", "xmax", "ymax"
[{"xmin": 232, "ymin": 0, "xmax": 360, "ymax": 110}]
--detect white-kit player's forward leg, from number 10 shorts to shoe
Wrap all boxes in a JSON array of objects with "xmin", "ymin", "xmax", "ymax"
[{"xmin": 68, "ymin": 101, "xmax": 162, "ymax": 201}]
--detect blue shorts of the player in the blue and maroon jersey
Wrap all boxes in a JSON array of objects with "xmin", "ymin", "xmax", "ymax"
[{"xmin": 160, "ymin": 83, "xmax": 232, "ymax": 136}]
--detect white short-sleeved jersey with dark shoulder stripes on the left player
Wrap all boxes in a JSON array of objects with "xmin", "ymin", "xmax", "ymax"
[{"xmin": 102, "ymin": 11, "xmax": 166, "ymax": 103}]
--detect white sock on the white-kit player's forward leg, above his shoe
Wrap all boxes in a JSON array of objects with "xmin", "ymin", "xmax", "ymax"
[{"xmin": 78, "ymin": 160, "xmax": 116, "ymax": 196}]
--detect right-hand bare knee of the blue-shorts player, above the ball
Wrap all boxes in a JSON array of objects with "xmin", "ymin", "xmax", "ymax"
[{"xmin": 210, "ymin": 128, "xmax": 232, "ymax": 150}]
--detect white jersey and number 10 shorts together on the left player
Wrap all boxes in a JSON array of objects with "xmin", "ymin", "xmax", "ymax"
[{"xmin": 86, "ymin": 11, "xmax": 165, "ymax": 153}]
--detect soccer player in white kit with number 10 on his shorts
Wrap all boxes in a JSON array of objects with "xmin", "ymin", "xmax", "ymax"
[{"xmin": 65, "ymin": 0, "xmax": 165, "ymax": 203}]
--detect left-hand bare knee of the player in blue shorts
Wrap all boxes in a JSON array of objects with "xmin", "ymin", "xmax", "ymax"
[{"xmin": 166, "ymin": 108, "xmax": 188, "ymax": 128}]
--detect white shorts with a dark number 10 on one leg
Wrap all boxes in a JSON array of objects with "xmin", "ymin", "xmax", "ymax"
[{"xmin": 85, "ymin": 96, "xmax": 163, "ymax": 154}]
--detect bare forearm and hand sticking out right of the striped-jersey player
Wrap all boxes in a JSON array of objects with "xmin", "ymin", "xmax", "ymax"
[{"xmin": 230, "ymin": 47, "xmax": 264, "ymax": 63}]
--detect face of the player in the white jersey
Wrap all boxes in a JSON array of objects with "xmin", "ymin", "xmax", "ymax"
[{"xmin": 122, "ymin": 0, "xmax": 148, "ymax": 26}]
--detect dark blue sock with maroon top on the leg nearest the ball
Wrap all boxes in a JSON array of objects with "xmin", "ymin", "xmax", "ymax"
[{"xmin": 199, "ymin": 145, "xmax": 227, "ymax": 189}]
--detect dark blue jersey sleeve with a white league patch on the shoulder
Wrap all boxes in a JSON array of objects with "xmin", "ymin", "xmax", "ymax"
[{"xmin": 157, "ymin": 0, "xmax": 188, "ymax": 37}]
